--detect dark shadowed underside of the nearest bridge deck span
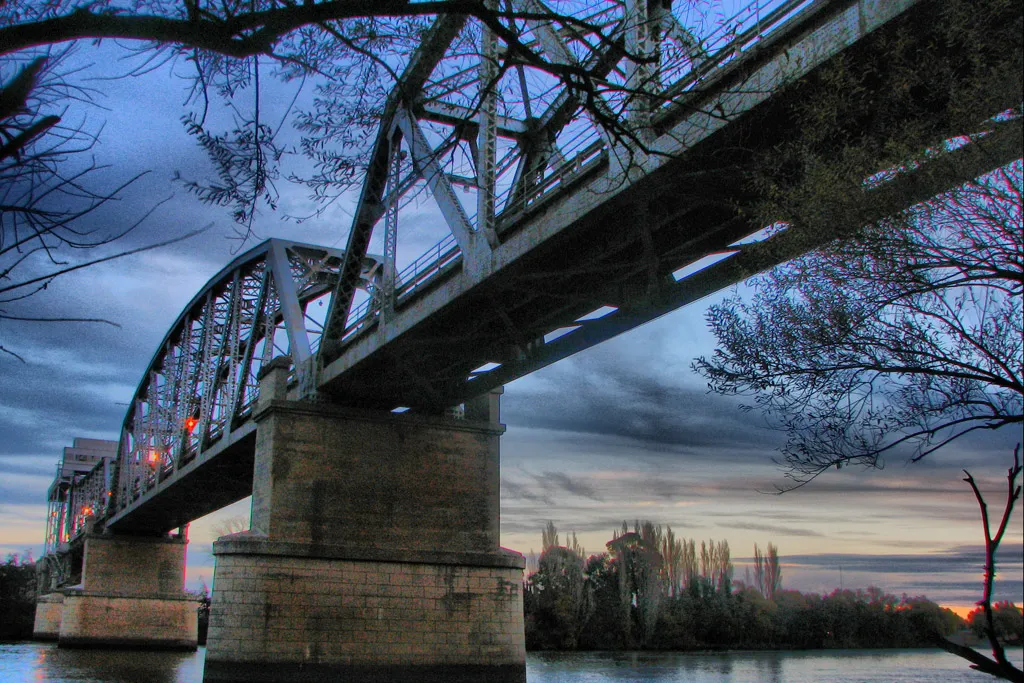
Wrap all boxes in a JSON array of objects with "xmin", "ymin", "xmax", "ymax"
[{"xmin": 322, "ymin": 2, "xmax": 1022, "ymax": 413}]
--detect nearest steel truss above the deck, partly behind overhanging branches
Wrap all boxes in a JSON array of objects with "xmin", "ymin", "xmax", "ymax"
[{"xmin": 317, "ymin": 0, "xmax": 812, "ymax": 368}]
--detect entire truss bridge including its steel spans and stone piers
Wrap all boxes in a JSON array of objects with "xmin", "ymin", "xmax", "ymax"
[{"xmin": 37, "ymin": 0, "xmax": 1022, "ymax": 681}]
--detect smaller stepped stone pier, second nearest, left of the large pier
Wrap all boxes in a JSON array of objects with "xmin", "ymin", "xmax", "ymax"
[{"xmin": 56, "ymin": 532, "xmax": 199, "ymax": 650}]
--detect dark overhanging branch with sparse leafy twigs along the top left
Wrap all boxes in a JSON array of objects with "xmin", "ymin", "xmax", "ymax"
[{"xmin": 0, "ymin": 0, "xmax": 720, "ymax": 225}]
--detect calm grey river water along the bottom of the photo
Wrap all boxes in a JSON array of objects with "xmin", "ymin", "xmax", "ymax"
[{"xmin": 0, "ymin": 643, "xmax": 1024, "ymax": 683}]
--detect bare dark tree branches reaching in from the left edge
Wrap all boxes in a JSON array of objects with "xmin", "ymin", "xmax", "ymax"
[{"xmin": 0, "ymin": 54, "xmax": 195, "ymax": 360}]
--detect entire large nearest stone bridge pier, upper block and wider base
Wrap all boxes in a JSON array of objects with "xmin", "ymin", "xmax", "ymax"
[{"xmin": 205, "ymin": 364, "xmax": 526, "ymax": 683}]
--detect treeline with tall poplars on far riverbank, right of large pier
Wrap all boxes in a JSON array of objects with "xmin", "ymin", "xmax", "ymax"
[{"xmin": 523, "ymin": 521, "xmax": 974, "ymax": 650}]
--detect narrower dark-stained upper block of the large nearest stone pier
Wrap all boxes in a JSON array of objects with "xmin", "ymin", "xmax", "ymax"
[{"xmin": 251, "ymin": 401, "xmax": 502, "ymax": 552}]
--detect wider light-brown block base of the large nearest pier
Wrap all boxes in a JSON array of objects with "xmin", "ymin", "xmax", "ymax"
[{"xmin": 204, "ymin": 537, "xmax": 525, "ymax": 683}]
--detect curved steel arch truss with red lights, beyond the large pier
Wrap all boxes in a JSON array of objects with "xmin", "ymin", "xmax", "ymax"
[{"xmin": 101, "ymin": 240, "xmax": 344, "ymax": 514}]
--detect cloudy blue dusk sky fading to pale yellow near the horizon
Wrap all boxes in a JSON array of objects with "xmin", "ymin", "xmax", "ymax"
[{"xmin": 0, "ymin": 22, "xmax": 1024, "ymax": 609}]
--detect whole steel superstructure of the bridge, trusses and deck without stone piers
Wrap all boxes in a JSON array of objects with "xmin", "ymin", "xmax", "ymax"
[{"xmin": 48, "ymin": 0, "xmax": 1021, "ymax": 548}]
